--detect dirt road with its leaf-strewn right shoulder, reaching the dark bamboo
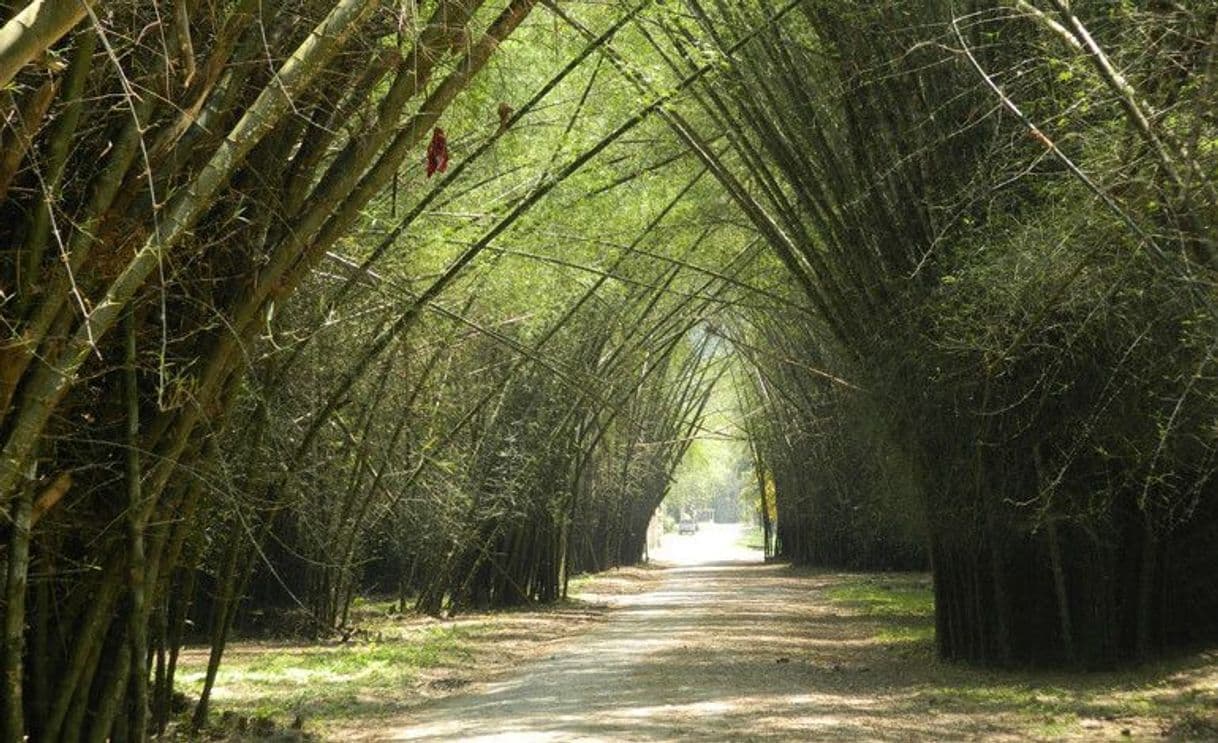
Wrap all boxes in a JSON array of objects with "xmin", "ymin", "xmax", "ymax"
[{"xmin": 373, "ymin": 526, "xmax": 1214, "ymax": 742}]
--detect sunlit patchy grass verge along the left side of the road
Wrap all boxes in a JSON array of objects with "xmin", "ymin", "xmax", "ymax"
[{"xmin": 177, "ymin": 568, "xmax": 658, "ymax": 741}]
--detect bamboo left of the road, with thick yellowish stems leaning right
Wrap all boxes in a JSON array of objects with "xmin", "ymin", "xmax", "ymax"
[{"xmin": 0, "ymin": 0, "xmax": 735, "ymax": 741}]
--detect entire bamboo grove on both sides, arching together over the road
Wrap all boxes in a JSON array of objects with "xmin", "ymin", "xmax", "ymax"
[{"xmin": 0, "ymin": 0, "xmax": 1218, "ymax": 741}]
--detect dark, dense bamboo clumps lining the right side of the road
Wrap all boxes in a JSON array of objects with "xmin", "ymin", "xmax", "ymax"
[{"xmin": 711, "ymin": 0, "xmax": 1218, "ymax": 665}]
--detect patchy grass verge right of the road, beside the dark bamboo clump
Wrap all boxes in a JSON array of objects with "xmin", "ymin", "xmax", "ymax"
[{"xmin": 825, "ymin": 574, "xmax": 1218, "ymax": 741}]
